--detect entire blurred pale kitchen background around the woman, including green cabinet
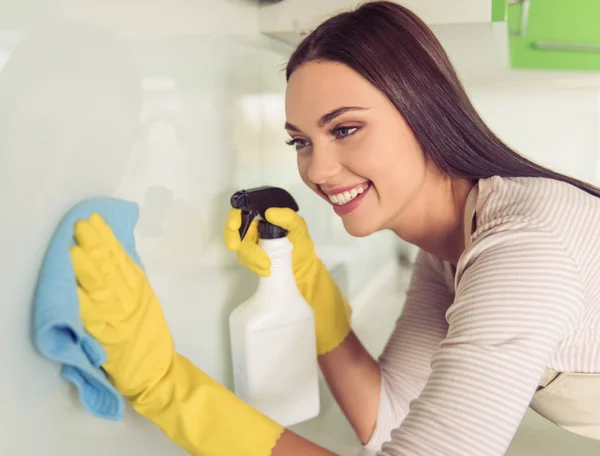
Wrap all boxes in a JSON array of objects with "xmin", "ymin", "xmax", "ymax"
[{"xmin": 0, "ymin": 0, "xmax": 600, "ymax": 456}]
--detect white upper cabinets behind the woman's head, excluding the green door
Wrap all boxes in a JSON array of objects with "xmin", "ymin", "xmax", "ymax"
[{"xmin": 260, "ymin": 0, "xmax": 600, "ymax": 89}]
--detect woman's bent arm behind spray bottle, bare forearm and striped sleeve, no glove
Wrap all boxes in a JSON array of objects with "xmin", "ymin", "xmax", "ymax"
[{"xmin": 310, "ymin": 252, "xmax": 454, "ymax": 450}]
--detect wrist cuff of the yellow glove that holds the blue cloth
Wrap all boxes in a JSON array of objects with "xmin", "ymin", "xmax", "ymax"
[{"xmin": 133, "ymin": 354, "xmax": 284, "ymax": 456}]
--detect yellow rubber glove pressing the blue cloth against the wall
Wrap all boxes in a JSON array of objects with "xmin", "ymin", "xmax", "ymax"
[{"xmin": 71, "ymin": 214, "xmax": 283, "ymax": 456}]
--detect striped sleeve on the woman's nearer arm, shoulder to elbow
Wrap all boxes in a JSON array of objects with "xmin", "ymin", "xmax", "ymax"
[{"xmin": 378, "ymin": 226, "xmax": 583, "ymax": 456}]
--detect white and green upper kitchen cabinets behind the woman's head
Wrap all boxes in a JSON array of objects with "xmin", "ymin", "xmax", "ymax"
[{"xmin": 260, "ymin": 0, "xmax": 600, "ymax": 89}]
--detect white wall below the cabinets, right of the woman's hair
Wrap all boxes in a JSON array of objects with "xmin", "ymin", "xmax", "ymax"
[{"xmin": 469, "ymin": 86, "xmax": 600, "ymax": 185}]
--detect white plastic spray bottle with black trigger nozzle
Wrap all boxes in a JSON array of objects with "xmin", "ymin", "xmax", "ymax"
[{"xmin": 229, "ymin": 187, "xmax": 320, "ymax": 427}]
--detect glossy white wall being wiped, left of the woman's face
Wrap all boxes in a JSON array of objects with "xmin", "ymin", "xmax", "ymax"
[{"xmin": 0, "ymin": 0, "xmax": 400, "ymax": 456}]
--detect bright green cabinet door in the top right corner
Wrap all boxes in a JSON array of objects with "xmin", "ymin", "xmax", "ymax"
[{"xmin": 506, "ymin": 0, "xmax": 600, "ymax": 72}]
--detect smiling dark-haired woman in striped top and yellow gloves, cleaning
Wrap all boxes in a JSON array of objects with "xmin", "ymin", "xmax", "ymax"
[{"xmin": 73, "ymin": 2, "xmax": 600, "ymax": 456}]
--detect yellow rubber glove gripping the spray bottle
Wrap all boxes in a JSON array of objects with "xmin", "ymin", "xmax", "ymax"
[{"xmin": 225, "ymin": 208, "xmax": 351, "ymax": 355}]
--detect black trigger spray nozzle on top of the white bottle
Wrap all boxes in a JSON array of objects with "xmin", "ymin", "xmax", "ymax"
[{"xmin": 231, "ymin": 186, "xmax": 298, "ymax": 239}]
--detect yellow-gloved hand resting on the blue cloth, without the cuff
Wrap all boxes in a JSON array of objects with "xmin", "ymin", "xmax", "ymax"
[{"xmin": 71, "ymin": 214, "xmax": 175, "ymax": 400}]
